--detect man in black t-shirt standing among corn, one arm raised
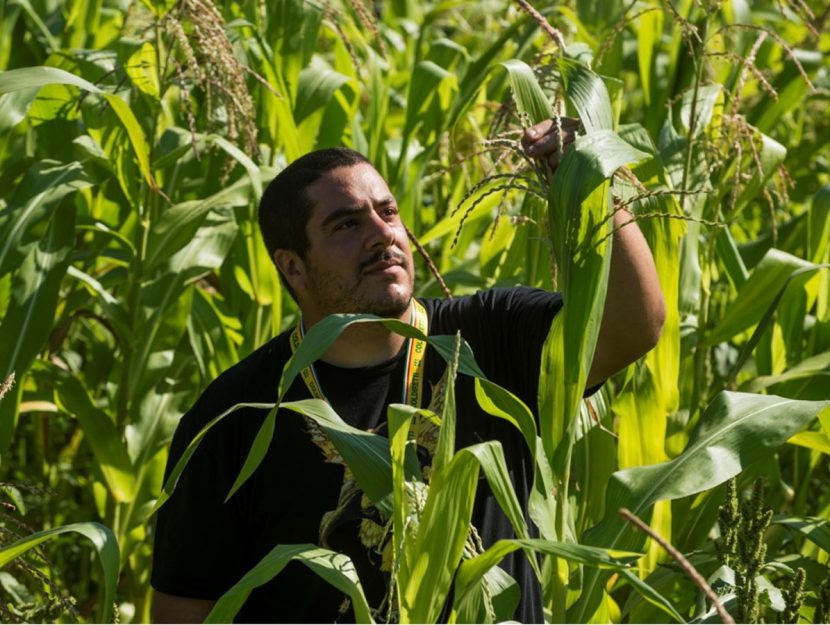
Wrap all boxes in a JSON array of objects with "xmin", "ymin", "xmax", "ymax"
[{"xmin": 152, "ymin": 121, "xmax": 664, "ymax": 622}]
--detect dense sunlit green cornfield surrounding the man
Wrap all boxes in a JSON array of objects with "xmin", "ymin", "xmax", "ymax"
[{"xmin": 0, "ymin": 0, "xmax": 830, "ymax": 623}]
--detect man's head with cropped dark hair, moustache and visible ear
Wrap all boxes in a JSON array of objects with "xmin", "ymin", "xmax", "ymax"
[{"xmin": 259, "ymin": 148, "xmax": 413, "ymax": 320}]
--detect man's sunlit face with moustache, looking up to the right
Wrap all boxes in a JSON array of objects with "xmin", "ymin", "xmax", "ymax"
[{"xmin": 290, "ymin": 163, "xmax": 414, "ymax": 318}]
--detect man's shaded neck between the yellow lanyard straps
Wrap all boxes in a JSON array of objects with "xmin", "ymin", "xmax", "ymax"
[{"xmin": 306, "ymin": 306, "xmax": 412, "ymax": 369}]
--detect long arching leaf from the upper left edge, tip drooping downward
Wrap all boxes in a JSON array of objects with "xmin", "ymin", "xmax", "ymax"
[{"xmin": 0, "ymin": 66, "xmax": 158, "ymax": 190}]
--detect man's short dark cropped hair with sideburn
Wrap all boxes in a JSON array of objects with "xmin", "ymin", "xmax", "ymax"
[{"xmin": 259, "ymin": 148, "xmax": 371, "ymax": 299}]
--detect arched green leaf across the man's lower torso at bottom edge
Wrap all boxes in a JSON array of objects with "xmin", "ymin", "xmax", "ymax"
[{"xmin": 205, "ymin": 545, "xmax": 375, "ymax": 623}]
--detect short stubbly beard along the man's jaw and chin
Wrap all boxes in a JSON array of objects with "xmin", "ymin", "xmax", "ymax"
[{"xmin": 309, "ymin": 249, "xmax": 413, "ymax": 318}]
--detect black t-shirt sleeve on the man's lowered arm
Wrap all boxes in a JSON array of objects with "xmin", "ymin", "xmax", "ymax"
[{"xmin": 151, "ymin": 388, "xmax": 250, "ymax": 599}]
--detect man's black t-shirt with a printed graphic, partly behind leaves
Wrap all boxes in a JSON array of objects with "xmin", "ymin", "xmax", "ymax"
[{"xmin": 152, "ymin": 287, "xmax": 562, "ymax": 623}]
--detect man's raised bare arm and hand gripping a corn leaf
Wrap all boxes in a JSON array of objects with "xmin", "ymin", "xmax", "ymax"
[{"xmin": 522, "ymin": 118, "xmax": 666, "ymax": 388}]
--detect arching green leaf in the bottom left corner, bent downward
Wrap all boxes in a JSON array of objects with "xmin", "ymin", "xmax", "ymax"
[{"xmin": 0, "ymin": 523, "xmax": 120, "ymax": 623}]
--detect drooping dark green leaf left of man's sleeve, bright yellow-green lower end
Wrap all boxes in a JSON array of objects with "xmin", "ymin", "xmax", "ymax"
[{"xmin": 35, "ymin": 361, "xmax": 136, "ymax": 503}]
